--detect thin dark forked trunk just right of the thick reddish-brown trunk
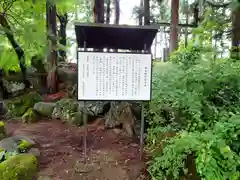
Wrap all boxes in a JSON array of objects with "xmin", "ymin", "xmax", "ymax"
[{"xmin": 57, "ymin": 13, "xmax": 68, "ymax": 61}]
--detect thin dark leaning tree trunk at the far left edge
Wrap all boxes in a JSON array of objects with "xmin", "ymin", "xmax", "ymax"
[{"xmin": 0, "ymin": 13, "xmax": 30, "ymax": 88}]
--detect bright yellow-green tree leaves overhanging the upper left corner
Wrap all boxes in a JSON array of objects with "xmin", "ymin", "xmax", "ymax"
[{"xmin": 0, "ymin": 0, "xmax": 91, "ymax": 72}]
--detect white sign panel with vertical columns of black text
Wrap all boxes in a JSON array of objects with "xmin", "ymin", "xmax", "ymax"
[{"xmin": 78, "ymin": 52, "xmax": 152, "ymax": 101}]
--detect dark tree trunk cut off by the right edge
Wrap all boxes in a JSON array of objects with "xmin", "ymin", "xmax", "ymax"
[{"xmin": 231, "ymin": 7, "xmax": 240, "ymax": 59}]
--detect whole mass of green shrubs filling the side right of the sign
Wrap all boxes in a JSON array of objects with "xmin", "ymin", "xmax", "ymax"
[{"xmin": 147, "ymin": 7, "xmax": 240, "ymax": 180}]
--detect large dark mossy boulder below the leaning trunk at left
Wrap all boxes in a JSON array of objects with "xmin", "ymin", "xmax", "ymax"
[{"xmin": 7, "ymin": 92, "xmax": 43, "ymax": 117}]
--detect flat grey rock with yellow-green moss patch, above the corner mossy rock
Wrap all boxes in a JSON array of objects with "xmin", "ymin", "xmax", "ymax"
[{"xmin": 0, "ymin": 136, "xmax": 36, "ymax": 152}]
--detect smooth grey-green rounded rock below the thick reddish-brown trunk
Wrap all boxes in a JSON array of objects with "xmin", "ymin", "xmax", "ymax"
[{"xmin": 33, "ymin": 102, "xmax": 56, "ymax": 117}]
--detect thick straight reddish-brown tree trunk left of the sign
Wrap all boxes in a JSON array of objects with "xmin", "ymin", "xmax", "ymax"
[{"xmin": 46, "ymin": 0, "xmax": 57, "ymax": 93}]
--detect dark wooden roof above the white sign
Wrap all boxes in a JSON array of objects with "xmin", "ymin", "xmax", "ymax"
[{"xmin": 75, "ymin": 22, "xmax": 159, "ymax": 50}]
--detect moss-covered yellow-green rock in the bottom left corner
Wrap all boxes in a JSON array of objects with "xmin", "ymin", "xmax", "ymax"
[{"xmin": 0, "ymin": 154, "xmax": 38, "ymax": 180}]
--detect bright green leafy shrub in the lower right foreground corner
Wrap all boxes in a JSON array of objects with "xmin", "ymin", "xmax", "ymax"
[{"xmin": 149, "ymin": 116, "xmax": 240, "ymax": 180}]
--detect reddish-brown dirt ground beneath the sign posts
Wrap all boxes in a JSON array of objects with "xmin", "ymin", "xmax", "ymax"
[{"xmin": 7, "ymin": 120, "xmax": 145, "ymax": 180}]
